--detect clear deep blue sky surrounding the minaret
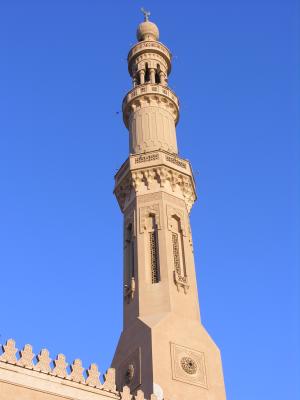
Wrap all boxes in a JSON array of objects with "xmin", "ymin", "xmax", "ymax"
[{"xmin": 0, "ymin": 0, "xmax": 299, "ymax": 400}]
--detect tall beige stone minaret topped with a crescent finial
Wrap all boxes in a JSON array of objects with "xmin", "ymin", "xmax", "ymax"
[{"xmin": 112, "ymin": 12, "xmax": 226, "ymax": 400}]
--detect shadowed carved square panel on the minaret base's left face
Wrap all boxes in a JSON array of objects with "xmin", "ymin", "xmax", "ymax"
[{"xmin": 117, "ymin": 347, "xmax": 141, "ymax": 391}]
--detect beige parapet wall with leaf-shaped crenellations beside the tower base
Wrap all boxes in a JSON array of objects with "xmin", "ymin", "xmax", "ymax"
[{"xmin": 0, "ymin": 339, "xmax": 156, "ymax": 400}]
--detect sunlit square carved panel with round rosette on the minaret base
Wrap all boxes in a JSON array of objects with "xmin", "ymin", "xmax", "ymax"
[{"xmin": 171, "ymin": 343, "xmax": 207, "ymax": 389}]
